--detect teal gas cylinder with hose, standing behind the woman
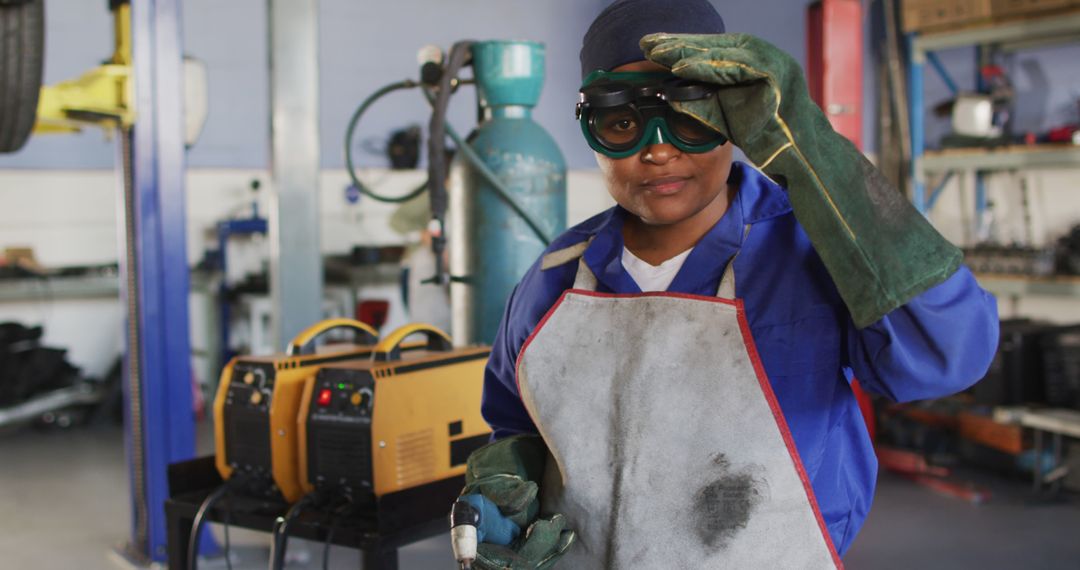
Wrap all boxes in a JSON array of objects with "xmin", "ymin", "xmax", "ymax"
[{"xmin": 451, "ymin": 41, "xmax": 566, "ymax": 344}]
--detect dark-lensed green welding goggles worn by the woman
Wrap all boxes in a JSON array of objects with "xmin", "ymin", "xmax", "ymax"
[{"xmin": 575, "ymin": 71, "xmax": 727, "ymax": 159}]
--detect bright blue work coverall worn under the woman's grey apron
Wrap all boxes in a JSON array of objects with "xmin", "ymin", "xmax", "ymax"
[{"xmin": 483, "ymin": 162, "xmax": 999, "ymax": 555}]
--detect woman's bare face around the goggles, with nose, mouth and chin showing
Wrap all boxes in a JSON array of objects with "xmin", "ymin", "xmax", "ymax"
[{"xmin": 596, "ymin": 62, "xmax": 732, "ymax": 226}]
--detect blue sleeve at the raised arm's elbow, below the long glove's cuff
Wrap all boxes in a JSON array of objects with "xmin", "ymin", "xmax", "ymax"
[{"xmin": 847, "ymin": 267, "xmax": 1000, "ymax": 402}]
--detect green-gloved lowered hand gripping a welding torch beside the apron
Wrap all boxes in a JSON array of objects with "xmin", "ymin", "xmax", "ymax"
[{"xmin": 461, "ymin": 435, "xmax": 575, "ymax": 570}]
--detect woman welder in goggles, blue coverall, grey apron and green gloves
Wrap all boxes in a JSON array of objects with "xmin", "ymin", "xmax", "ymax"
[{"xmin": 453, "ymin": 0, "xmax": 998, "ymax": 569}]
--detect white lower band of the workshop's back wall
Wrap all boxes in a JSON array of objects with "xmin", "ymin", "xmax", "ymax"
[{"xmin": 6, "ymin": 159, "xmax": 1080, "ymax": 375}]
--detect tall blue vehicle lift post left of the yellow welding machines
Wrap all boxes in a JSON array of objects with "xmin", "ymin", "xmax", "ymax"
[{"xmin": 118, "ymin": 0, "xmax": 194, "ymax": 560}]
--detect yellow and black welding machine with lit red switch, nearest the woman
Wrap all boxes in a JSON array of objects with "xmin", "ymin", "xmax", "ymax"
[{"xmin": 298, "ymin": 324, "xmax": 491, "ymax": 505}]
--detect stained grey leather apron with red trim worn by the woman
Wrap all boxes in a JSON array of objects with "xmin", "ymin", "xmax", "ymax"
[{"xmin": 517, "ymin": 247, "xmax": 842, "ymax": 570}]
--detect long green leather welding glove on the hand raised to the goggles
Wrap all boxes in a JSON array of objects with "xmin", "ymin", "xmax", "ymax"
[{"xmin": 640, "ymin": 33, "xmax": 962, "ymax": 328}]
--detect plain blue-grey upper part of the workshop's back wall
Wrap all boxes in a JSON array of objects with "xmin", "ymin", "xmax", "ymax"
[{"xmin": 0, "ymin": 0, "xmax": 825, "ymax": 168}]
